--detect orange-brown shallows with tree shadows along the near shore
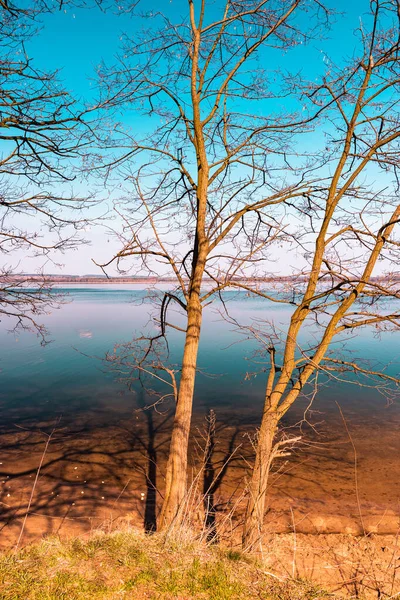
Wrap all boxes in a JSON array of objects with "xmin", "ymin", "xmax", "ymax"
[{"xmin": 0, "ymin": 400, "xmax": 400, "ymax": 548}]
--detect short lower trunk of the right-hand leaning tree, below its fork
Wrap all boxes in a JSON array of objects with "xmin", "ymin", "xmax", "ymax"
[{"xmin": 242, "ymin": 412, "xmax": 278, "ymax": 551}]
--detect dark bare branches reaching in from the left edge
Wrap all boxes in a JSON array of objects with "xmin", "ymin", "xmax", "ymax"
[{"xmin": 0, "ymin": 0, "xmax": 97, "ymax": 340}]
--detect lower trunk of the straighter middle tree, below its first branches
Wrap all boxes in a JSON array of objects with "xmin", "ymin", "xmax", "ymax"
[{"xmin": 159, "ymin": 294, "xmax": 202, "ymax": 530}]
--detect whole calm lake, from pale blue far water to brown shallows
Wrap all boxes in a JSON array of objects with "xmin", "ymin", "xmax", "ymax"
[{"xmin": 0, "ymin": 286, "xmax": 400, "ymax": 543}]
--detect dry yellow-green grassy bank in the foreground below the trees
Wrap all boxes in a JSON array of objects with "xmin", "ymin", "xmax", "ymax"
[{"xmin": 0, "ymin": 530, "xmax": 332, "ymax": 600}]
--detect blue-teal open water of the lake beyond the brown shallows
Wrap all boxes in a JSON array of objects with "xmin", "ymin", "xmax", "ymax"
[{"xmin": 0, "ymin": 286, "xmax": 400, "ymax": 427}]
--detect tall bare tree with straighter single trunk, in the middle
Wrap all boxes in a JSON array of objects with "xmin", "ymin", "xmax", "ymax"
[{"xmin": 95, "ymin": 0, "xmax": 328, "ymax": 527}]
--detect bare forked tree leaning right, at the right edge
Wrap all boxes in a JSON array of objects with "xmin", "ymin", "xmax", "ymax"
[{"xmin": 243, "ymin": 0, "xmax": 400, "ymax": 548}]
